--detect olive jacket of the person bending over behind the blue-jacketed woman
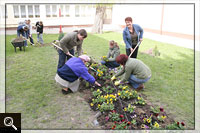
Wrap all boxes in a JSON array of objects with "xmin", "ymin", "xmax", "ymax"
[{"xmin": 60, "ymin": 32, "xmax": 83, "ymax": 56}]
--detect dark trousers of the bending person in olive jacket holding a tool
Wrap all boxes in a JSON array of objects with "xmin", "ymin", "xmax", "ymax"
[{"xmin": 57, "ymin": 49, "xmax": 74, "ymax": 69}]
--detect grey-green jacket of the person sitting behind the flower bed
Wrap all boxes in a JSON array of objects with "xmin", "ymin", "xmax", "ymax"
[{"xmin": 107, "ymin": 46, "xmax": 120, "ymax": 61}]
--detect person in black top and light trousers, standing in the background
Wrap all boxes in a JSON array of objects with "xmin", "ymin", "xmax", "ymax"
[{"xmin": 35, "ymin": 21, "xmax": 44, "ymax": 44}]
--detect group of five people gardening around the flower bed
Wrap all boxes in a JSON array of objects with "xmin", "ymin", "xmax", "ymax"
[{"xmin": 55, "ymin": 17, "xmax": 151, "ymax": 94}]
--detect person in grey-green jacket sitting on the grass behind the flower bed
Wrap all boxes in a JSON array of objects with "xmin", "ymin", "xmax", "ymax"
[{"xmin": 101, "ymin": 40, "xmax": 120, "ymax": 69}]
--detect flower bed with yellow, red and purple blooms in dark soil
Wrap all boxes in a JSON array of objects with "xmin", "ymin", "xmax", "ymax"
[{"xmin": 81, "ymin": 64, "xmax": 185, "ymax": 129}]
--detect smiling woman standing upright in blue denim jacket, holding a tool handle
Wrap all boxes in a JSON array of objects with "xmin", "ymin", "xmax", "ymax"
[{"xmin": 123, "ymin": 17, "xmax": 143, "ymax": 58}]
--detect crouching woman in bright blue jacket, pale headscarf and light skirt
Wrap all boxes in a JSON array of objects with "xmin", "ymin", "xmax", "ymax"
[{"xmin": 55, "ymin": 55, "xmax": 101, "ymax": 94}]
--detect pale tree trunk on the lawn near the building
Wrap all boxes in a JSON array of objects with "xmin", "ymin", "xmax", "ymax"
[{"xmin": 92, "ymin": 5, "xmax": 106, "ymax": 34}]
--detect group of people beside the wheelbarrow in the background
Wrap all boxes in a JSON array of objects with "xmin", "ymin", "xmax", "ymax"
[{"xmin": 17, "ymin": 19, "xmax": 44, "ymax": 47}]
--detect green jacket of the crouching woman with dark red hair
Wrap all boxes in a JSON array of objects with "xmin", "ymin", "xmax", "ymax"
[{"xmin": 115, "ymin": 58, "xmax": 151, "ymax": 82}]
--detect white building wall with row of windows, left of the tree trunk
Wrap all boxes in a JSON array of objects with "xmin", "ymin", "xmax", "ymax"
[{"xmin": 6, "ymin": 4, "xmax": 96, "ymax": 27}]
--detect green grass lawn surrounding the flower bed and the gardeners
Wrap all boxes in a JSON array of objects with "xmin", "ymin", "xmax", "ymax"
[{"xmin": 6, "ymin": 32, "xmax": 194, "ymax": 129}]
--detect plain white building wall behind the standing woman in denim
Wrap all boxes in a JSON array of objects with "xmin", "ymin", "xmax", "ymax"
[{"xmin": 112, "ymin": 4, "xmax": 194, "ymax": 37}]
